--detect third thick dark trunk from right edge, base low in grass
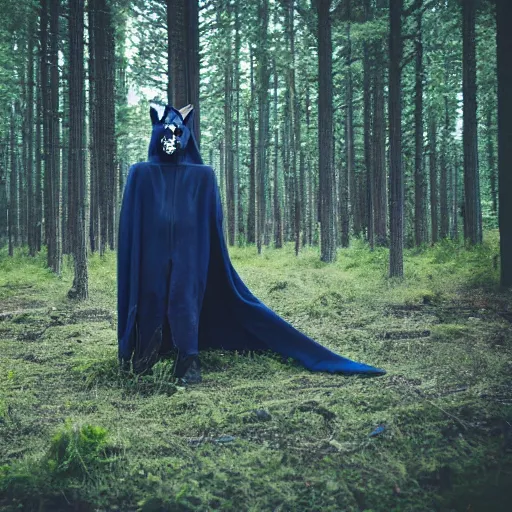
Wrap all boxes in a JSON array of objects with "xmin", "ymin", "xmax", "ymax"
[{"xmin": 389, "ymin": 0, "xmax": 404, "ymax": 277}]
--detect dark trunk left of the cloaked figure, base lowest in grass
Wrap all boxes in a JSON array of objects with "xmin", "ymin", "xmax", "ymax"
[{"xmin": 68, "ymin": 0, "xmax": 88, "ymax": 299}]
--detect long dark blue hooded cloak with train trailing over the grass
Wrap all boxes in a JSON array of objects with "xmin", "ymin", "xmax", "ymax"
[{"xmin": 117, "ymin": 106, "xmax": 385, "ymax": 375}]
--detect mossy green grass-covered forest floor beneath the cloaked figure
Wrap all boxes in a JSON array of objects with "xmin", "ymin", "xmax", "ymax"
[{"xmin": 0, "ymin": 232, "xmax": 512, "ymax": 512}]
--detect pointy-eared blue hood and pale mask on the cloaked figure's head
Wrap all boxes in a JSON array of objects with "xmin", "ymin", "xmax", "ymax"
[{"xmin": 148, "ymin": 104, "xmax": 203, "ymax": 164}]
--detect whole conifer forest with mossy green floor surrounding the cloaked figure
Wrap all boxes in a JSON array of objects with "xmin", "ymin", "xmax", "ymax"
[{"xmin": 0, "ymin": 0, "xmax": 512, "ymax": 512}]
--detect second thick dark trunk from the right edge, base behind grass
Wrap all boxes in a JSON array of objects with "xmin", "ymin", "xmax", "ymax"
[{"xmin": 462, "ymin": 0, "xmax": 482, "ymax": 244}]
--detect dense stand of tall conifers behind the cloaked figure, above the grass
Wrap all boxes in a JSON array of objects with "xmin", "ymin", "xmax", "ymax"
[{"xmin": 0, "ymin": 0, "xmax": 512, "ymax": 297}]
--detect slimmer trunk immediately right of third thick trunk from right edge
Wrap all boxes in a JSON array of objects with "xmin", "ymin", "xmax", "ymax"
[{"xmin": 414, "ymin": 0, "xmax": 427, "ymax": 246}]
